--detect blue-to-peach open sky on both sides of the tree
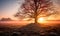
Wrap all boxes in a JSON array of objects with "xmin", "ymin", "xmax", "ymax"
[{"xmin": 0, "ymin": 0, "xmax": 60, "ymax": 20}]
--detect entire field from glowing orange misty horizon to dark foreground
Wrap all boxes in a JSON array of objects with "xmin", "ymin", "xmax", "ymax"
[{"xmin": 0, "ymin": 21, "xmax": 60, "ymax": 36}]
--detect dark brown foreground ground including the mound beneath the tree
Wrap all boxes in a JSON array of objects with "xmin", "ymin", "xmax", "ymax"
[{"xmin": 0, "ymin": 23, "xmax": 60, "ymax": 36}]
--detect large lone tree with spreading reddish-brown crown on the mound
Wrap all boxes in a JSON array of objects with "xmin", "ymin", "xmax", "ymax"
[{"xmin": 15, "ymin": 0, "xmax": 56, "ymax": 23}]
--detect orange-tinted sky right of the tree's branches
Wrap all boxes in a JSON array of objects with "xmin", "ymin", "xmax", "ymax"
[{"xmin": 48, "ymin": 0, "xmax": 60, "ymax": 20}]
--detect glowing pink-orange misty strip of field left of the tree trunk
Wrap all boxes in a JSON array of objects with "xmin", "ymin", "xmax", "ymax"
[{"xmin": 0, "ymin": 21, "xmax": 31, "ymax": 28}]
